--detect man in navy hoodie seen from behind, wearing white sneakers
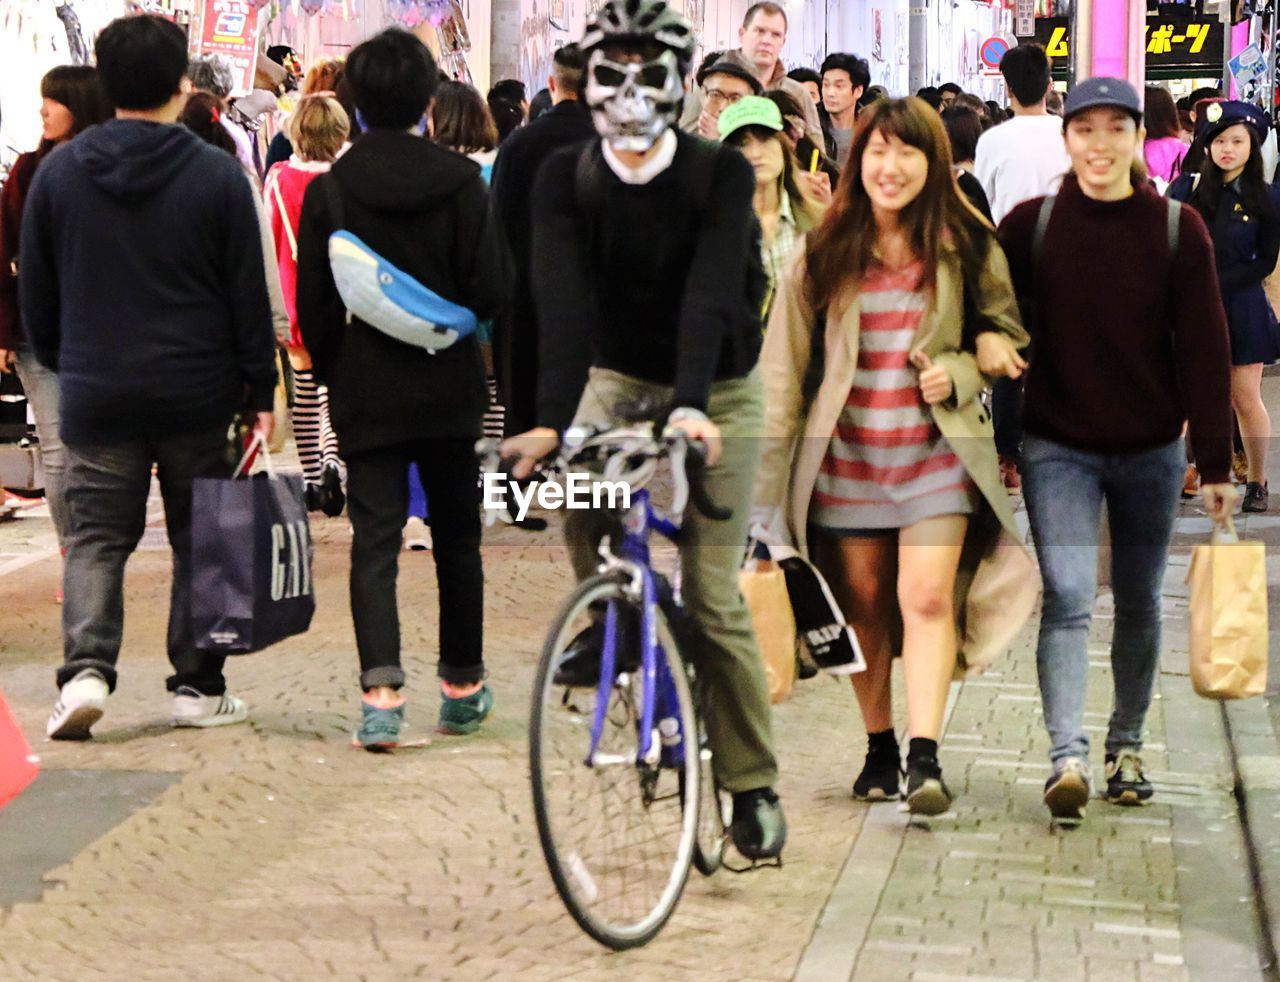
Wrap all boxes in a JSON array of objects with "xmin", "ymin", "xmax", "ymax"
[{"xmin": 18, "ymin": 17, "xmax": 275, "ymax": 740}]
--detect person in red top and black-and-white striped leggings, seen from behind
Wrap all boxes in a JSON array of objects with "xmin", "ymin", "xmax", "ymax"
[{"xmin": 262, "ymin": 92, "xmax": 351, "ymax": 515}]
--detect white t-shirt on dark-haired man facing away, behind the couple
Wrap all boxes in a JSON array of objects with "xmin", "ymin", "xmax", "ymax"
[{"xmin": 973, "ymin": 115, "xmax": 1071, "ymax": 224}]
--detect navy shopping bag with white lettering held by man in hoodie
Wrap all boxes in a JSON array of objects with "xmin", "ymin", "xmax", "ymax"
[{"xmin": 191, "ymin": 435, "xmax": 316, "ymax": 654}]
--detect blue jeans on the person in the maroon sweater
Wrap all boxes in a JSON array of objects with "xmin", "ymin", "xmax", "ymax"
[{"xmin": 1021, "ymin": 434, "xmax": 1187, "ymax": 761}]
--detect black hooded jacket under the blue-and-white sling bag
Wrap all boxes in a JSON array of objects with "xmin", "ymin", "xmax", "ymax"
[{"xmin": 298, "ymin": 129, "xmax": 511, "ymax": 453}]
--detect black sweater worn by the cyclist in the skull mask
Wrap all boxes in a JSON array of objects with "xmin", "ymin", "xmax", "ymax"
[{"xmin": 532, "ymin": 133, "xmax": 762, "ymax": 430}]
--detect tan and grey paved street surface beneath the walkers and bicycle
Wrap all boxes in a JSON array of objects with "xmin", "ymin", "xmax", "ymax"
[{"xmin": 0, "ymin": 486, "xmax": 1274, "ymax": 982}]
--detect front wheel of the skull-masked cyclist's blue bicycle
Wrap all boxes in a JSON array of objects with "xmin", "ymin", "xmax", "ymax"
[{"xmin": 529, "ymin": 576, "xmax": 701, "ymax": 950}]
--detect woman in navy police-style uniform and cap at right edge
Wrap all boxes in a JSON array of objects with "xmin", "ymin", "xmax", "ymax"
[{"xmin": 1169, "ymin": 101, "xmax": 1280, "ymax": 512}]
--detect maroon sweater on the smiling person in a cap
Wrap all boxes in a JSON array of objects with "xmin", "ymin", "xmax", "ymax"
[{"xmin": 1000, "ymin": 177, "xmax": 1231, "ymax": 484}]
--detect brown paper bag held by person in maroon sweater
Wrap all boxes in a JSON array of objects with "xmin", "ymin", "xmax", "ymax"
[{"xmin": 1187, "ymin": 519, "xmax": 1267, "ymax": 699}]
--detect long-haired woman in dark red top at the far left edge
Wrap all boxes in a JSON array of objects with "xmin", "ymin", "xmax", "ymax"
[{"xmin": 0, "ymin": 65, "xmax": 114, "ymax": 553}]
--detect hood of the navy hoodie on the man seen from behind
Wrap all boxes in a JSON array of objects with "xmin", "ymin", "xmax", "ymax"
[{"xmin": 70, "ymin": 119, "xmax": 207, "ymax": 198}]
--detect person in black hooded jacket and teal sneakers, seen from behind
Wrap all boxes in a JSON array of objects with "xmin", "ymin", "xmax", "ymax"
[{"xmin": 297, "ymin": 29, "xmax": 512, "ymax": 750}]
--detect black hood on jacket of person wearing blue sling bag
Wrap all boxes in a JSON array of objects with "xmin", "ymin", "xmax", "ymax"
[{"xmin": 330, "ymin": 129, "xmax": 480, "ymax": 211}]
